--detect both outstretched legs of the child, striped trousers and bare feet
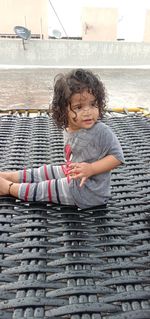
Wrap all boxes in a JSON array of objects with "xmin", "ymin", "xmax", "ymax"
[{"xmin": 0, "ymin": 165, "xmax": 74, "ymax": 205}]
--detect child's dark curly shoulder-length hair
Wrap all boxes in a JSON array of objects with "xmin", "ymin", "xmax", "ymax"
[{"xmin": 51, "ymin": 69, "xmax": 106, "ymax": 128}]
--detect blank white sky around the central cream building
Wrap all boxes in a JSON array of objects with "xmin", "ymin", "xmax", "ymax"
[{"xmin": 49, "ymin": 0, "xmax": 150, "ymax": 41}]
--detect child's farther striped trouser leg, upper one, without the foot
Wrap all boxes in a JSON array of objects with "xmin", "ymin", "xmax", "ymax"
[{"xmin": 19, "ymin": 164, "xmax": 66, "ymax": 183}]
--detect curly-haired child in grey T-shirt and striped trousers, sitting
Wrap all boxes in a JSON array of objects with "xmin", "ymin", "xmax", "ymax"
[{"xmin": 0, "ymin": 69, "xmax": 124, "ymax": 208}]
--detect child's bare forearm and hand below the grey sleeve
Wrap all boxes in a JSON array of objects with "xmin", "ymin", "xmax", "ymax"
[{"xmin": 69, "ymin": 155, "xmax": 121, "ymax": 186}]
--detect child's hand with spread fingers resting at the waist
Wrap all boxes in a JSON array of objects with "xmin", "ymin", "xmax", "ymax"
[{"xmin": 68, "ymin": 162, "xmax": 93, "ymax": 187}]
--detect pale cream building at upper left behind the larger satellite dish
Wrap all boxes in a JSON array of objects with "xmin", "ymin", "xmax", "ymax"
[{"xmin": 0, "ymin": 0, "xmax": 48, "ymax": 39}]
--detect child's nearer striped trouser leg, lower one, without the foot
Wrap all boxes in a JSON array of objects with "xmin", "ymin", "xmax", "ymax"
[{"xmin": 18, "ymin": 177, "xmax": 75, "ymax": 205}]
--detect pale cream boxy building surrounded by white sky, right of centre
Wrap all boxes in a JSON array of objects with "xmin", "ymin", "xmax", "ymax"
[{"xmin": 81, "ymin": 7, "xmax": 118, "ymax": 41}]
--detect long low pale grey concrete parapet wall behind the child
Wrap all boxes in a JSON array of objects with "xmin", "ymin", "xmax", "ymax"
[{"xmin": 0, "ymin": 39, "xmax": 150, "ymax": 67}]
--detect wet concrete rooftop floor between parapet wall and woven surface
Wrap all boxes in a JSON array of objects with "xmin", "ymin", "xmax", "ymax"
[{"xmin": 0, "ymin": 67, "xmax": 150, "ymax": 111}]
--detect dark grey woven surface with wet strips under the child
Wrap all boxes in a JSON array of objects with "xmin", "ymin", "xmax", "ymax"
[{"xmin": 0, "ymin": 115, "xmax": 150, "ymax": 319}]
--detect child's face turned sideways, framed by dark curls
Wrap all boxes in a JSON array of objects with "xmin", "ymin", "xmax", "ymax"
[{"xmin": 68, "ymin": 90, "xmax": 99, "ymax": 131}]
